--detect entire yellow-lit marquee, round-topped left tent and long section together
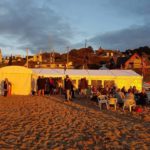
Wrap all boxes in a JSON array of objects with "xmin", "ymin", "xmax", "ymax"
[{"xmin": 0, "ymin": 66, "xmax": 143, "ymax": 95}]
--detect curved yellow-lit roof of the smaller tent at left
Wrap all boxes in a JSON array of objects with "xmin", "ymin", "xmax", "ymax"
[{"xmin": 0, "ymin": 66, "xmax": 32, "ymax": 74}]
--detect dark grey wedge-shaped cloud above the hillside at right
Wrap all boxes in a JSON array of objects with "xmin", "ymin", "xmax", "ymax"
[{"xmin": 89, "ymin": 24, "xmax": 150, "ymax": 50}]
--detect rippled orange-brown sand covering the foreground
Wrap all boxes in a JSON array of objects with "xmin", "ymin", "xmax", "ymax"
[{"xmin": 0, "ymin": 96, "xmax": 150, "ymax": 150}]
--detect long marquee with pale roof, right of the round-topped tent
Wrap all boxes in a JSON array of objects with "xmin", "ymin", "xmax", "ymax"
[{"xmin": 32, "ymin": 69, "xmax": 143, "ymax": 91}]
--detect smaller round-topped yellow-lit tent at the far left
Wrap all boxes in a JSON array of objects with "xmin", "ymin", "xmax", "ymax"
[{"xmin": 0, "ymin": 66, "xmax": 32, "ymax": 95}]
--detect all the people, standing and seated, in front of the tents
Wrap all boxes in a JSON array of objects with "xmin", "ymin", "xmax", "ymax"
[{"xmin": 3, "ymin": 75, "xmax": 148, "ymax": 110}]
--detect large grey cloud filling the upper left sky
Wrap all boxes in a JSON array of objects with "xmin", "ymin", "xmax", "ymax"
[{"xmin": 0, "ymin": 0, "xmax": 73, "ymax": 53}]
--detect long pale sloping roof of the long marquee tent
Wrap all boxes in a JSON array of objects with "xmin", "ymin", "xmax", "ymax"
[{"xmin": 32, "ymin": 68, "xmax": 141, "ymax": 77}]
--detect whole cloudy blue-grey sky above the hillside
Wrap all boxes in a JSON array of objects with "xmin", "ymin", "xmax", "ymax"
[{"xmin": 0, "ymin": 0, "xmax": 150, "ymax": 55}]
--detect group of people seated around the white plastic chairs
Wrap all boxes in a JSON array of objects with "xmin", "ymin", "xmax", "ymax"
[{"xmin": 91, "ymin": 85, "xmax": 148, "ymax": 106}]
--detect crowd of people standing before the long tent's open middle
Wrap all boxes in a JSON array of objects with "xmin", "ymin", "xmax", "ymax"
[{"xmin": 34, "ymin": 75, "xmax": 88, "ymax": 101}]
